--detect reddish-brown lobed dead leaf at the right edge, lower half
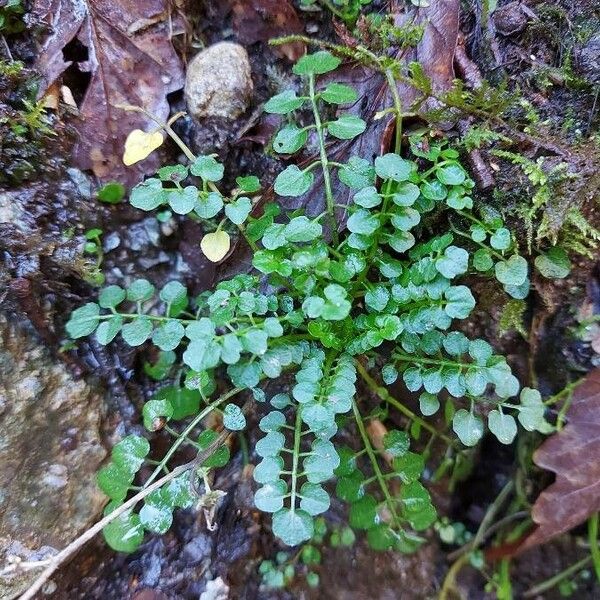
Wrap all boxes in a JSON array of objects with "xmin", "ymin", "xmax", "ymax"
[{"xmin": 519, "ymin": 369, "xmax": 600, "ymax": 551}]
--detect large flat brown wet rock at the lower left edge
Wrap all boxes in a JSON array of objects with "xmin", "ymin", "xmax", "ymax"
[{"xmin": 0, "ymin": 315, "xmax": 106, "ymax": 598}]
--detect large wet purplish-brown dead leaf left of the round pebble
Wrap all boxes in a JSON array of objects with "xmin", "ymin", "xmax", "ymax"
[{"xmin": 33, "ymin": 0, "xmax": 183, "ymax": 183}]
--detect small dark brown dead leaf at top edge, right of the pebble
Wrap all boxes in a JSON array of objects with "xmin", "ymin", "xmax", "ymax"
[{"xmin": 231, "ymin": 0, "xmax": 305, "ymax": 61}]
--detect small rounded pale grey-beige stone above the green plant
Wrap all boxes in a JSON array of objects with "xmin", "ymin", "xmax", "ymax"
[{"xmin": 185, "ymin": 42, "xmax": 254, "ymax": 119}]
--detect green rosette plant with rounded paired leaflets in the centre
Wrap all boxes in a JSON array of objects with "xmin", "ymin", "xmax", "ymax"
[{"xmin": 67, "ymin": 51, "xmax": 545, "ymax": 552}]
